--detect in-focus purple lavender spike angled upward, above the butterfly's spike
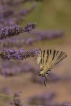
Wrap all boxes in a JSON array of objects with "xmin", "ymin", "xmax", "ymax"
[{"xmin": 0, "ymin": 23, "xmax": 36, "ymax": 39}]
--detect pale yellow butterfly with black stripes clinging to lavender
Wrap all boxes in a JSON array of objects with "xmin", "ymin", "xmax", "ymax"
[{"xmin": 37, "ymin": 49, "xmax": 67, "ymax": 86}]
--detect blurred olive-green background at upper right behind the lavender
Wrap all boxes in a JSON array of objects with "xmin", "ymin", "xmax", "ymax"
[{"xmin": 20, "ymin": 0, "xmax": 71, "ymax": 44}]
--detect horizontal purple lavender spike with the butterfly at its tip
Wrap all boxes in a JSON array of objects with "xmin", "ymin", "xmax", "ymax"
[{"xmin": 0, "ymin": 48, "xmax": 38, "ymax": 60}]
